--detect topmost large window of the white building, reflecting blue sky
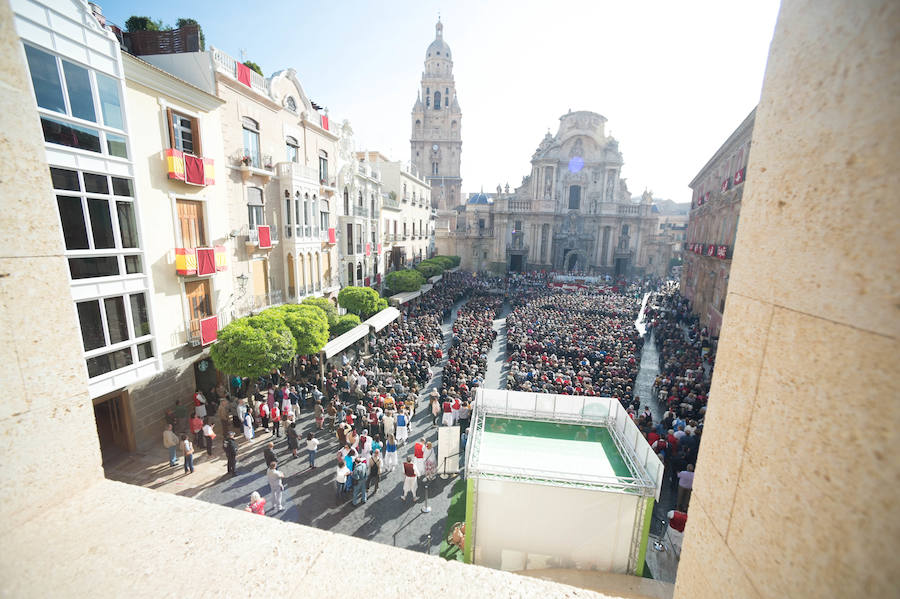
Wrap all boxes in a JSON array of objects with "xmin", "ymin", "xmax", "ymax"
[{"xmin": 25, "ymin": 45, "xmax": 128, "ymax": 158}]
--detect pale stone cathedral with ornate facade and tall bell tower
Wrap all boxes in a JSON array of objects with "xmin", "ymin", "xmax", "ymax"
[{"xmin": 410, "ymin": 21, "xmax": 671, "ymax": 277}]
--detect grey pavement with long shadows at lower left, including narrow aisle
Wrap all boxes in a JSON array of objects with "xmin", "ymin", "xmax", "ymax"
[{"xmin": 106, "ymin": 302, "xmax": 462, "ymax": 554}]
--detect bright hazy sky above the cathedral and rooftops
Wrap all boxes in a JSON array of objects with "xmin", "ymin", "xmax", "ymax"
[{"xmin": 98, "ymin": 0, "xmax": 779, "ymax": 202}]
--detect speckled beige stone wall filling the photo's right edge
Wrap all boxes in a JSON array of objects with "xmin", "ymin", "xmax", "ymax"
[{"xmin": 676, "ymin": 0, "xmax": 900, "ymax": 599}]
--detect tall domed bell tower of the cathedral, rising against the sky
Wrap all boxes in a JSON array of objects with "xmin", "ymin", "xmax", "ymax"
[{"xmin": 410, "ymin": 20, "xmax": 462, "ymax": 210}]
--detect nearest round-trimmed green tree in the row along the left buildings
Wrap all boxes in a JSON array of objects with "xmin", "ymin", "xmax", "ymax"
[{"xmin": 209, "ymin": 314, "xmax": 297, "ymax": 378}]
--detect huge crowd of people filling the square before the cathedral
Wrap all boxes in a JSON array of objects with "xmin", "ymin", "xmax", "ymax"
[{"xmin": 164, "ymin": 272, "xmax": 713, "ymax": 514}]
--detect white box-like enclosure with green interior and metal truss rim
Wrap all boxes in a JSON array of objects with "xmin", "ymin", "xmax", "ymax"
[{"xmin": 464, "ymin": 389, "xmax": 663, "ymax": 575}]
